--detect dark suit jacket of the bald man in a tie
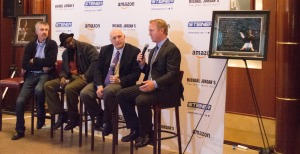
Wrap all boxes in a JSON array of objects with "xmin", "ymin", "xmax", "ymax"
[{"xmin": 94, "ymin": 43, "xmax": 141, "ymax": 88}]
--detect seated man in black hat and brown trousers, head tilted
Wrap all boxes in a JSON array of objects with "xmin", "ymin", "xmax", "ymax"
[{"xmin": 44, "ymin": 33, "xmax": 98, "ymax": 130}]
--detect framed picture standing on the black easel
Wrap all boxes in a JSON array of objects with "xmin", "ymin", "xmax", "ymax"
[{"xmin": 208, "ymin": 11, "xmax": 270, "ymax": 60}]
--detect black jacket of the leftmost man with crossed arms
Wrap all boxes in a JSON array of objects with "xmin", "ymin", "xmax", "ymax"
[{"xmin": 22, "ymin": 37, "xmax": 58, "ymax": 78}]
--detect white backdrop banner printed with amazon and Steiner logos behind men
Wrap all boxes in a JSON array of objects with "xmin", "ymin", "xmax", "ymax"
[{"xmin": 51, "ymin": 0, "xmax": 230, "ymax": 154}]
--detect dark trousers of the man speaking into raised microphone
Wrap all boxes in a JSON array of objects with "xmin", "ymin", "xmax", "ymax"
[{"xmin": 117, "ymin": 85, "xmax": 158, "ymax": 135}]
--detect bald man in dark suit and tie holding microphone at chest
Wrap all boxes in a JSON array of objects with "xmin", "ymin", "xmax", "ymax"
[{"xmin": 80, "ymin": 29, "xmax": 140, "ymax": 136}]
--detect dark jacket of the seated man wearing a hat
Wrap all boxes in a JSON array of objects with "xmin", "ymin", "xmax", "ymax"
[{"xmin": 59, "ymin": 40, "xmax": 99, "ymax": 82}]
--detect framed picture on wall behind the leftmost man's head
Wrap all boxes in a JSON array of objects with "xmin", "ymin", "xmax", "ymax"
[{"xmin": 14, "ymin": 14, "xmax": 47, "ymax": 46}]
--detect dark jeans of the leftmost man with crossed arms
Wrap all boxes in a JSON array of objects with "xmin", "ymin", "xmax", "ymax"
[{"xmin": 16, "ymin": 73, "xmax": 49, "ymax": 132}]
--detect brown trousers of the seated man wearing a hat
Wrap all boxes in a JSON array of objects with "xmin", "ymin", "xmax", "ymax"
[{"xmin": 44, "ymin": 75, "xmax": 88, "ymax": 120}]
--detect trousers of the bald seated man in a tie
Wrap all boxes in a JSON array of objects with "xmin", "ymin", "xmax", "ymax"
[{"xmin": 80, "ymin": 83, "xmax": 122, "ymax": 122}]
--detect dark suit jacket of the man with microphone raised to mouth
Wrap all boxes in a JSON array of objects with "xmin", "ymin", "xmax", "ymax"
[{"xmin": 142, "ymin": 39, "xmax": 183, "ymax": 107}]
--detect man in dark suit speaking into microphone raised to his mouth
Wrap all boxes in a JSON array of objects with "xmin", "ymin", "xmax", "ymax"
[{"xmin": 117, "ymin": 19, "xmax": 182, "ymax": 147}]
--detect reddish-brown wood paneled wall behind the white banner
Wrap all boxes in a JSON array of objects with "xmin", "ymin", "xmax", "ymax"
[{"xmin": 0, "ymin": 0, "xmax": 276, "ymax": 118}]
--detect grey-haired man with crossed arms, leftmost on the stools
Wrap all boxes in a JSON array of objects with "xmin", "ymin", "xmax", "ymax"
[{"xmin": 11, "ymin": 22, "xmax": 58, "ymax": 140}]
